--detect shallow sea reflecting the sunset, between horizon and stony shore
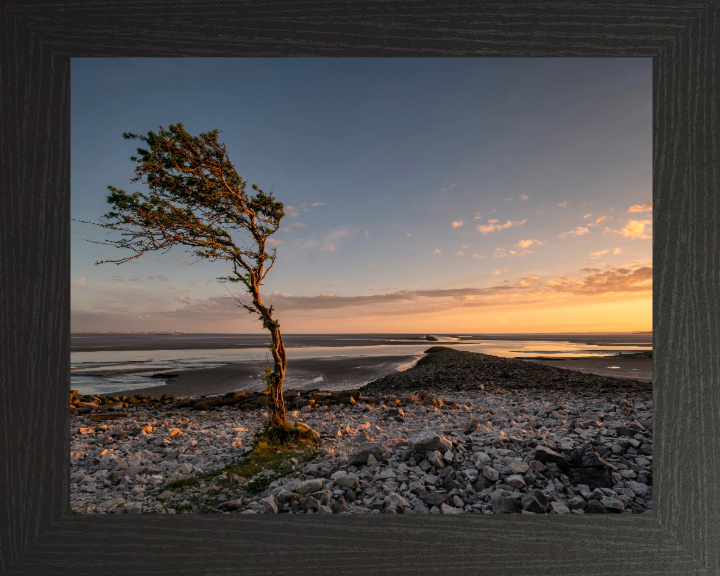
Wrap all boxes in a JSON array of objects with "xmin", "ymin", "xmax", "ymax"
[{"xmin": 70, "ymin": 332, "xmax": 652, "ymax": 395}]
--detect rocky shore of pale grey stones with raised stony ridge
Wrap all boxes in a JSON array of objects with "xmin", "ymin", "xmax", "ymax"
[{"xmin": 71, "ymin": 346, "xmax": 653, "ymax": 514}]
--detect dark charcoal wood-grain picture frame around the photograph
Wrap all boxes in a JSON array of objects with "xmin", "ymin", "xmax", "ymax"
[{"xmin": 0, "ymin": 0, "xmax": 720, "ymax": 576}]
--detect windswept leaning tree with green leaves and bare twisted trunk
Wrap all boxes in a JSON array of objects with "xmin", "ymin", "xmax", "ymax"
[{"xmin": 90, "ymin": 124, "xmax": 288, "ymax": 429}]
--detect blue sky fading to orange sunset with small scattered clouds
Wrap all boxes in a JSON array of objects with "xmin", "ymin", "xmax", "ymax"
[{"xmin": 71, "ymin": 58, "xmax": 652, "ymax": 334}]
